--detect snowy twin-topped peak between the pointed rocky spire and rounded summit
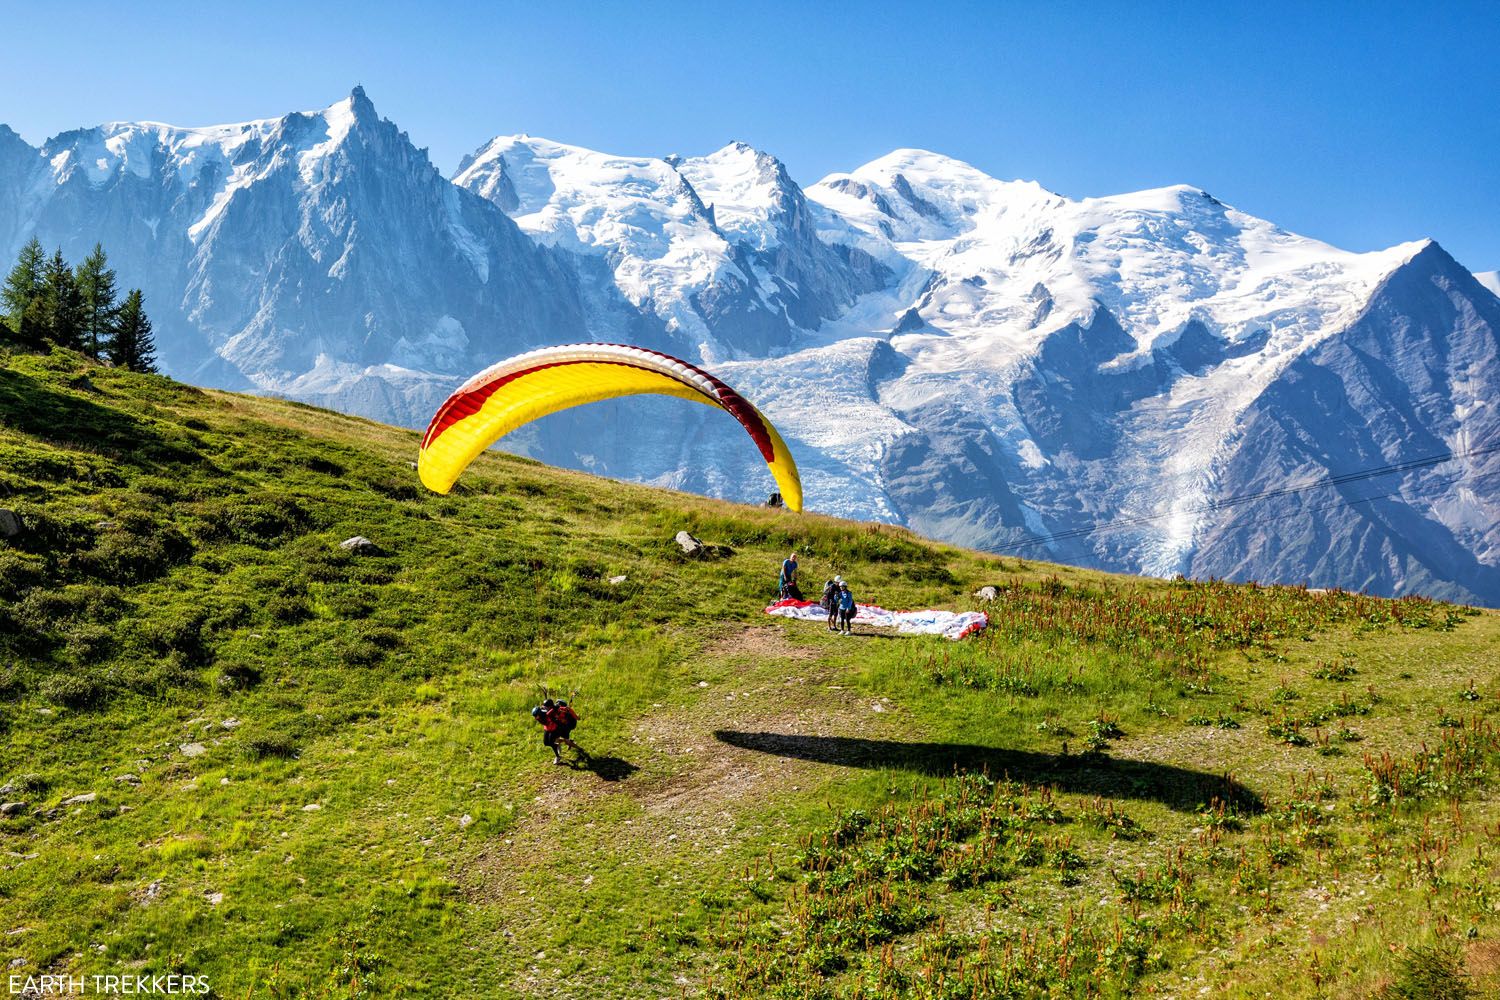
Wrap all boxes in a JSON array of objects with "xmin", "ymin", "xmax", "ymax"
[{"xmin": 453, "ymin": 135, "xmax": 887, "ymax": 361}]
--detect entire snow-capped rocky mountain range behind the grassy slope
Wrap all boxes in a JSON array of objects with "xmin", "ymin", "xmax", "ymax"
[{"xmin": 0, "ymin": 90, "xmax": 1500, "ymax": 604}]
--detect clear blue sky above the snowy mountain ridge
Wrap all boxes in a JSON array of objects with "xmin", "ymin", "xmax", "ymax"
[{"xmin": 0, "ymin": 0, "xmax": 1500, "ymax": 270}]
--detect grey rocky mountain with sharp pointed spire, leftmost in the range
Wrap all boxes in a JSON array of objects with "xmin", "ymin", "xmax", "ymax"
[{"xmin": 0, "ymin": 88, "xmax": 587, "ymax": 423}]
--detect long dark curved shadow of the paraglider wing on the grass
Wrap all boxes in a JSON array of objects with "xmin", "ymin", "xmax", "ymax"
[{"xmin": 714, "ymin": 730, "xmax": 1265, "ymax": 813}]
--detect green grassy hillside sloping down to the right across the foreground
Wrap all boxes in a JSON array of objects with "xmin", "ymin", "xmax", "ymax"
[{"xmin": 0, "ymin": 346, "xmax": 1500, "ymax": 1000}]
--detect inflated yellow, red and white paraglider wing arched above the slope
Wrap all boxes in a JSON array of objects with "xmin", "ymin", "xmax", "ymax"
[{"xmin": 417, "ymin": 343, "xmax": 803, "ymax": 511}]
